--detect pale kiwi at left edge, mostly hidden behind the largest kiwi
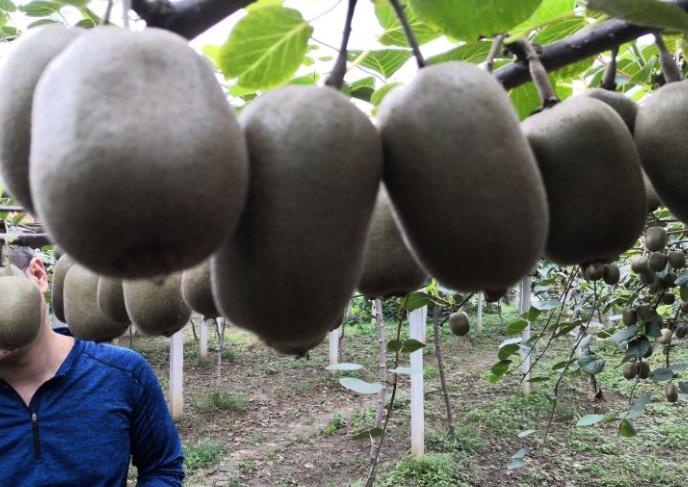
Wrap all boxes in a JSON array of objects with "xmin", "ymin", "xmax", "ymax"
[{"xmin": 0, "ymin": 24, "xmax": 84, "ymax": 213}]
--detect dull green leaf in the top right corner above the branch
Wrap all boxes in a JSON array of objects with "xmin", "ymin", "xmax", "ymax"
[{"xmin": 588, "ymin": 0, "xmax": 688, "ymax": 31}]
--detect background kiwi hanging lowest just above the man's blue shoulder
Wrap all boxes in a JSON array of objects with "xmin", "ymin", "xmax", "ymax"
[{"xmin": 63, "ymin": 263, "xmax": 128, "ymax": 342}]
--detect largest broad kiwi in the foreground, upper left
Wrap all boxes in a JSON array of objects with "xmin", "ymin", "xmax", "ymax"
[{"xmin": 30, "ymin": 26, "xmax": 248, "ymax": 279}]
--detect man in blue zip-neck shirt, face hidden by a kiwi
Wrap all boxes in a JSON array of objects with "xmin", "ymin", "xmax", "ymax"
[{"xmin": 0, "ymin": 249, "xmax": 184, "ymax": 487}]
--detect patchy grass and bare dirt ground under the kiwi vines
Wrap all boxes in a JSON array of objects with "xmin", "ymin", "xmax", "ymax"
[{"xmin": 122, "ymin": 304, "xmax": 688, "ymax": 487}]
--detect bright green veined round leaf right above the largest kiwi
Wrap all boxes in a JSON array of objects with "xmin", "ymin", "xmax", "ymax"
[{"xmin": 218, "ymin": 5, "xmax": 313, "ymax": 90}]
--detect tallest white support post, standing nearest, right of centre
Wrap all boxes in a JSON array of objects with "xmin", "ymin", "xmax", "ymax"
[{"xmin": 408, "ymin": 306, "xmax": 428, "ymax": 458}]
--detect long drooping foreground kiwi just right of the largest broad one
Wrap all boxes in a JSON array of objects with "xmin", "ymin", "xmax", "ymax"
[{"xmin": 211, "ymin": 85, "xmax": 382, "ymax": 355}]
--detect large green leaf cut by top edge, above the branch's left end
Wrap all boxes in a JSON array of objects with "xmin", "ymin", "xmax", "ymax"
[{"xmin": 410, "ymin": 0, "xmax": 542, "ymax": 41}]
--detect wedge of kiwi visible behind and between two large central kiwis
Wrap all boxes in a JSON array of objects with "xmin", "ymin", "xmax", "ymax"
[{"xmin": 358, "ymin": 186, "xmax": 427, "ymax": 298}]
